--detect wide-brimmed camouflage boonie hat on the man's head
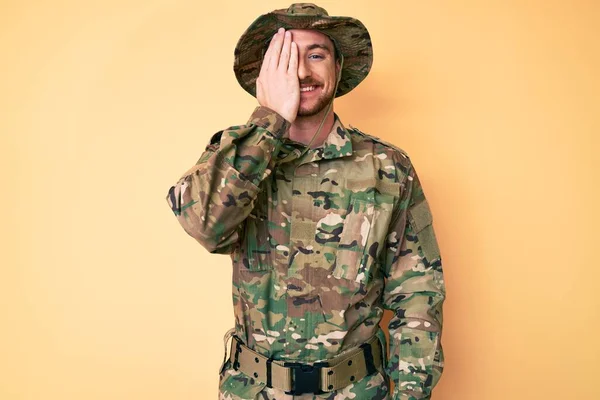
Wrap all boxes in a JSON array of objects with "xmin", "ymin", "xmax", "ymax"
[{"xmin": 233, "ymin": 3, "xmax": 373, "ymax": 97}]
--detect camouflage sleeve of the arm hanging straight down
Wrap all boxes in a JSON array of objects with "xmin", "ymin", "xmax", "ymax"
[{"xmin": 381, "ymin": 160, "xmax": 446, "ymax": 400}]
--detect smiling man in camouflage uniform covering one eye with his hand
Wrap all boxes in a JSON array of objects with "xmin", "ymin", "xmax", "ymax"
[{"xmin": 167, "ymin": 3, "xmax": 445, "ymax": 400}]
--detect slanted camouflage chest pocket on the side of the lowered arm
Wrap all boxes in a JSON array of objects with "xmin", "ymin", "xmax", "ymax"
[{"xmin": 333, "ymin": 192, "xmax": 394, "ymax": 283}]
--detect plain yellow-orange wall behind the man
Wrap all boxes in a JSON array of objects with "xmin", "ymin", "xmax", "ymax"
[{"xmin": 0, "ymin": 0, "xmax": 600, "ymax": 400}]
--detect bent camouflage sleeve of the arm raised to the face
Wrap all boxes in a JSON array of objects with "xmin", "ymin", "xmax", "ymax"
[{"xmin": 166, "ymin": 106, "xmax": 290, "ymax": 254}]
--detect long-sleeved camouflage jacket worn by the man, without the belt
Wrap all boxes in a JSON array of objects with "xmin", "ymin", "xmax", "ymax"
[{"xmin": 166, "ymin": 107, "xmax": 445, "ymax": 400}]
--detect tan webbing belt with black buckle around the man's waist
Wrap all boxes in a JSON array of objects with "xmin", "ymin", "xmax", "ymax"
[{"xmin": 225, "ymin": 331, "xmax": 383, "ymax": 395}]
